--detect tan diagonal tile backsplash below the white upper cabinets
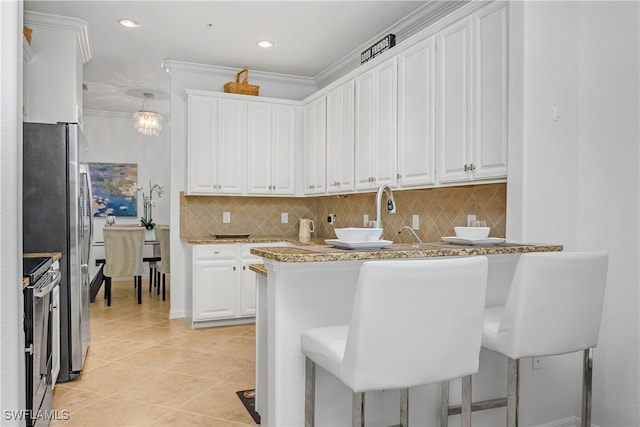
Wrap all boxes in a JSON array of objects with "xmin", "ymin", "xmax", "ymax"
[{"xmin": 180, "ymin": 183, "xmax": 507, "ymax": 242}]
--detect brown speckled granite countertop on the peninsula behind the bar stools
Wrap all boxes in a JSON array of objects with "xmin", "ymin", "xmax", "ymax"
[{"xmin": 251, "ymin": 242, "xmax": 563, "ymax": 262}]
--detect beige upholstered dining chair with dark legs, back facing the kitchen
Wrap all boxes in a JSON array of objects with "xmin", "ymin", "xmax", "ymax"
[{"xmin": 104, "ymin": 227, "xmax": 145, "ymax": 306}]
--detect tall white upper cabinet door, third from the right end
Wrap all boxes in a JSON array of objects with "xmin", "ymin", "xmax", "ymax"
[{"xmin": 398, "ymin": 37, "xmax": 436, "ymax": 187}]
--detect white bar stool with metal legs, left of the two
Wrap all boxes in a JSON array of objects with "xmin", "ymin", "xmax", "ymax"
[{"xmin": 301, "ymin": 256, "xmax": 488, "ymax": 427}]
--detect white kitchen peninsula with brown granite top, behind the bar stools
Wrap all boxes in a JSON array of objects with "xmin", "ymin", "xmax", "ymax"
[{"xmin": 251, "ymin": 243, "xmax": 563, "ymax": 427}]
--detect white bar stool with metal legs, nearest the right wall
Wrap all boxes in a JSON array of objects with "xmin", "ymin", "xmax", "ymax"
[{"xmin": 441, "ymin": 252, "xmax": 608, "ymax": 427}]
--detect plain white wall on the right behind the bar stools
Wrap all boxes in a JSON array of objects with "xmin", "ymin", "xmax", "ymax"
[{"xmin": 507, "ymin": 1, "xmax": 640, "ymax": 427}]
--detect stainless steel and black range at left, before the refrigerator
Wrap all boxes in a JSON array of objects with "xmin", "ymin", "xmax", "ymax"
[{"xmin": 23, "ymin": 257, "xmax": 61, "ymax": 427}]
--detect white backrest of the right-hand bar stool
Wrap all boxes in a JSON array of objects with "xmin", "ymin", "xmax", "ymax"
[{"xmin": 495, "ymin": 252, "xmax": 608, "ymax": 359}]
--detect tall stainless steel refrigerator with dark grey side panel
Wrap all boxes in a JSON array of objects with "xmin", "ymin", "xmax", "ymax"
[{"xmin": 22, "ymin": 123, "xmax": 93, "ymax": 382}]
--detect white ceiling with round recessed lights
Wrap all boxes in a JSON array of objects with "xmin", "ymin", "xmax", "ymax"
[{"xmin": 24, "ymin": 0, "xmax": 444, "ymax": 113}]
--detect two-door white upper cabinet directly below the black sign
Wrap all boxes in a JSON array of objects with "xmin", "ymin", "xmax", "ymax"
[{"xmin": 355, "ymin": 58, "xmax": 398, "ymax": 190}]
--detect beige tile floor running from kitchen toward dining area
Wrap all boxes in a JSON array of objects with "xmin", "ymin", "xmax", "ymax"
[{"xmin": 51, "ymin": 281, "xmax": 255, "ymax": 427}]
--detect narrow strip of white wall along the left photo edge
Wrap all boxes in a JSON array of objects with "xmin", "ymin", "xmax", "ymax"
[{"xmin": 0, "ymin": 1, "xmax": 25, "ymax": 426}]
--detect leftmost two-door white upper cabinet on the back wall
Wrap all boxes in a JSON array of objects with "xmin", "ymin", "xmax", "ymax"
[{"xmin": 187, "ymin": 95, "xmax": 247, "ymax": 194}]
